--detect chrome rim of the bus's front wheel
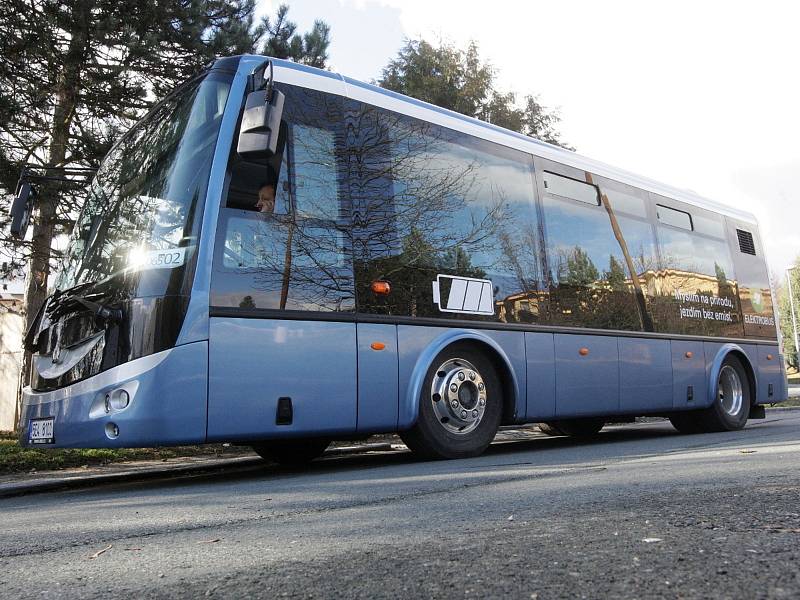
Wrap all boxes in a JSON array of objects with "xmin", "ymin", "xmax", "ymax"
[{"xmin": 431, "ymin": 358, "xmax": 486, "ymax": 435}]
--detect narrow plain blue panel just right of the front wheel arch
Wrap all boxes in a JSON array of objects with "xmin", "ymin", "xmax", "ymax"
[{"xmin": 525, "ymin": 333, "xmax": 556, "ymax": 421}]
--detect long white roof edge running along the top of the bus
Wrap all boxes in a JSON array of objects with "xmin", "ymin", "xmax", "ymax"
[{"xmin": 240, "ymin": 55, "xmax": 756, "ymax": 224}]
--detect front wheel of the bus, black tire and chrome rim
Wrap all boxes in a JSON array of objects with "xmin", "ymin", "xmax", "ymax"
[{"xmin": 400, "ymin": 344, "xmax": 503, "ymax": 459}]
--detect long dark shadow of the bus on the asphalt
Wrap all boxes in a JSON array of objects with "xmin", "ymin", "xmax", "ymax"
[{"xmin": 57, "ymin": 415, "xmax": 794, "ymax": 502}]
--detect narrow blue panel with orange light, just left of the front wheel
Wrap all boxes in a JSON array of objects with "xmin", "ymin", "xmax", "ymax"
[{"xmin": 357, "ymin": 323, "xmax": 398, "ymax": 433}]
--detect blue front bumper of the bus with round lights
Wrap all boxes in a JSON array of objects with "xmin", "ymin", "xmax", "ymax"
[{"xmin": 19, "ymin": 342, "xmax": 208, "ymax": 448}]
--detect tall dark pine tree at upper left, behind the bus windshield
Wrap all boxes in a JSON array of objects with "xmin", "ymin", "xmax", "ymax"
[{"xmin": 0, "ymin": 0, "xmax": 329, "ymax": 408}]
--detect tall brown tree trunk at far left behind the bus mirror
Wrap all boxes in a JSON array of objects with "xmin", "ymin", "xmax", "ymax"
[{"xmin": 15, "ymin": 2, "xmax": 93, "ymax": 427}]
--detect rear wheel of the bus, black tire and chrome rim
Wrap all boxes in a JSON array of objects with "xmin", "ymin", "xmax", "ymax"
[{"xmin": 669, "ymin": 355, "xmax": 752, "ymax": 433}]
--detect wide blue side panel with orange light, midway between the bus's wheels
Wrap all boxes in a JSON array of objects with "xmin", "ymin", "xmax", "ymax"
[{"xmin": 554, "ymin": 334, "xmax": 619, "ymax": 418}]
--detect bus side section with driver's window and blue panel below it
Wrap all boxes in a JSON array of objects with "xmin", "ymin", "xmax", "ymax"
[{"xmin": 208, "ymin": 85, "xmax": 357, "ymax": 441}]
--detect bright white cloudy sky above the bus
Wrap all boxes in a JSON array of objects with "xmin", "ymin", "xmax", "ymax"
[{"xmin": 257, "ymin": 0, "xmax": 800, "ymax": 278}]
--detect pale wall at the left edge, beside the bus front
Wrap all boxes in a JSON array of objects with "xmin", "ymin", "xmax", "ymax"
[{"xmin": 0, "ymin": 300, "xmax": 23, "ymax": 431}]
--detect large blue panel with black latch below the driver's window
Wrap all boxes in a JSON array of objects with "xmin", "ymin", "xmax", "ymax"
[{"xmin": 208, "ymin": 317, "xmax": 356, "ymax": 441}]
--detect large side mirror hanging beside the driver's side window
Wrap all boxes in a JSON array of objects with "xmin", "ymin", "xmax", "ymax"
[{"xmin": 237, "ymin": 89, "xmax": 286, "ymax": 159}]
